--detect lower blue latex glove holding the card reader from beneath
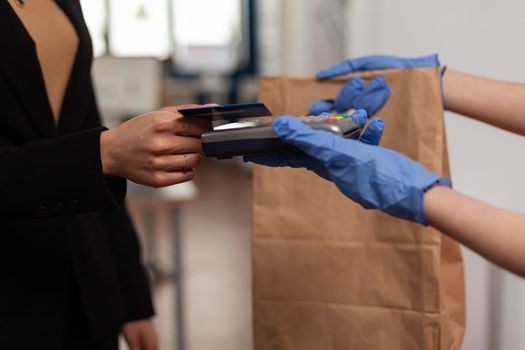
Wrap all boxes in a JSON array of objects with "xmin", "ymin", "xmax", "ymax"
[{"xmin": 245, "ymin": 116, "xmax": 450, "ymax": 224}]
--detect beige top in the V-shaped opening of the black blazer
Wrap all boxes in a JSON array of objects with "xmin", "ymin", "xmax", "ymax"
[{"xmin": 7, "ymin": 0, "xmax": 78, "ymax": 124}]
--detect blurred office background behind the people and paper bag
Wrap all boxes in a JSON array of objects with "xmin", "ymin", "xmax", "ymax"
[{"xmin": 82, "ymin": 0, "xmax": 525, "ymax": 350}]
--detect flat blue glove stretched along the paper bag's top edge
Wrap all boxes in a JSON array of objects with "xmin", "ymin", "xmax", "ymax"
[{"xmin": 317, "ymin": 55, "xmax": 440, "ymax": 79}]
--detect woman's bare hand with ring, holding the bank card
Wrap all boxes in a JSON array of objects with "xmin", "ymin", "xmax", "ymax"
[{"xmin": 100, "ymin": 105, "xmax": 211, "ymax": 187}]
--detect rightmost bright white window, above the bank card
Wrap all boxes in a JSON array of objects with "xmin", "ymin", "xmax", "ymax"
[{"xmin": 172, "ymin": 0, "xmax": 248, "ymax": 73}]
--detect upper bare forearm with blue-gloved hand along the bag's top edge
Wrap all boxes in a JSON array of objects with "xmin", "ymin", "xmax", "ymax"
[{"xmin": 317, "ymin": 55, "xmax": 525, "ymax": 135}]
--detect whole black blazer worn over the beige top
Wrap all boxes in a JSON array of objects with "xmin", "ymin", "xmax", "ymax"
[{"xmin": 0, "ymin": 0, "xmax": 153, "ymax": 349}]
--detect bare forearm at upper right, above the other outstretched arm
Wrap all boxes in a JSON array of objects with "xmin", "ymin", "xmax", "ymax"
[{"xmin": 443, "ymin": 70, "xmax": 525, "ymax": 135}]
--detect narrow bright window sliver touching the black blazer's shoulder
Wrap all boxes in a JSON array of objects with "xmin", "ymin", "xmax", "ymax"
[{"xmin": 80, "ymin": 0, "xmax": 107, "ymax": 57}]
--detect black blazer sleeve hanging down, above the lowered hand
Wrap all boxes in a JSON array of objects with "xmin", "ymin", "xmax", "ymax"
[{"xmin": 101, "ymin": 207, "xmax": 155, "ymax": 322}]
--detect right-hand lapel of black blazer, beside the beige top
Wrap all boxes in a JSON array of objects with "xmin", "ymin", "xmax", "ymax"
[{"xmin": 55, "ymin": 0, "xmax": 93, "ymax": 135}]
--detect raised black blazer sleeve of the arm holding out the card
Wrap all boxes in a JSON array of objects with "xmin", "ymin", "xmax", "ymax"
[{"xmin": 0, "ymin": 127, "xmax": 126, "ymax": 218}]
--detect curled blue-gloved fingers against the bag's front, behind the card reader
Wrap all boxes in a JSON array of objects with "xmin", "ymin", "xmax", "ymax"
[{"xmin": 309, "ymin": 77, "xmax": 390, "ymax": 115}]
